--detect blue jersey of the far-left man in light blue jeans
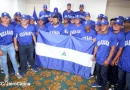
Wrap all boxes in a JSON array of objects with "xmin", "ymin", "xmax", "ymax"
[{"xmin": 0, "ymin": 24, "xmax": 14, "ymax": 45}]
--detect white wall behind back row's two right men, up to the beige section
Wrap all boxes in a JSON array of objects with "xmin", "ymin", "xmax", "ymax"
[{"xmin": 50, "ymin": 0, "xmax": 107, "ymax": 20}]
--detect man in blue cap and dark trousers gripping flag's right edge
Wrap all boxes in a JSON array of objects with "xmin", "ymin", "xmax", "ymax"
[{"xmin": 92, "ymin": 20, "xmax": 117, "ymax": 90}]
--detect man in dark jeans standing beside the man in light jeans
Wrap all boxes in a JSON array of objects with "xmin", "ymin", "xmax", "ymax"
[{"xmin": 14, "ymin": 15, "xmax": 38, "ymax": 76}]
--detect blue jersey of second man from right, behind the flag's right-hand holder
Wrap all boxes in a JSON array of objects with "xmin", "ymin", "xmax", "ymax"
[{"xmin": 112, "ymin": 31, "xmax": 125, "ymax": 60}]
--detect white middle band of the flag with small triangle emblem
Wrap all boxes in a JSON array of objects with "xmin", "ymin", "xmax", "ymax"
[{"xmin": 36, "ymin": 43, "xmax": 92, "ymax": 67}]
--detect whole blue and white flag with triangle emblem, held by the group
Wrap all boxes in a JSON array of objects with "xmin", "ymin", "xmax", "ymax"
[{"xmin": 36, "ymin": 31, "xmax": 94, "ymax": 78}]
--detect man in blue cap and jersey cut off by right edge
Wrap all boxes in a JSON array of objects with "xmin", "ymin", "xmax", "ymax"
[{"xmin": 117, "ymin": 17, "xmax": 130, "ymax": 90}]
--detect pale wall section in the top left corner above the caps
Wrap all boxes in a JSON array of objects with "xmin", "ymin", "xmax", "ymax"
[{"xmin": 0, "ymin": 0, "xmax": 18, "ymax": 17}]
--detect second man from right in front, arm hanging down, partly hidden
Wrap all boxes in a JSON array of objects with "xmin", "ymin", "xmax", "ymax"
[{"xmin": 109, "ymin": 19, "xmax": 125, "ymax": 89}]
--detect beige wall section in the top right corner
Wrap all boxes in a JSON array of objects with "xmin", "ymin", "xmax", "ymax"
[{"xmin": 106, "ymin": 0, "xmax": 130, "ymax": 19}]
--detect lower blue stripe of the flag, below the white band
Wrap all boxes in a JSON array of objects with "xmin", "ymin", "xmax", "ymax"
[{"xmin": 36, "ymin": 55, "xmax": 91, "ymax": 79}]
